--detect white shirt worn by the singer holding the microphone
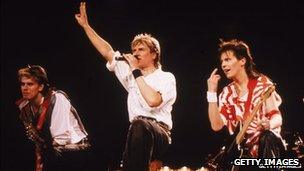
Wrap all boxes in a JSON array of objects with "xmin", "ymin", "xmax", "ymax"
[{"xmin": 106, "ymin": 51, "xmax": 176, "ymax": 129}]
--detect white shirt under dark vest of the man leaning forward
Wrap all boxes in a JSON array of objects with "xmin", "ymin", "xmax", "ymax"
[{"xmin": 50, "ymin": 93, "xmax": 87, "ymax": 145}]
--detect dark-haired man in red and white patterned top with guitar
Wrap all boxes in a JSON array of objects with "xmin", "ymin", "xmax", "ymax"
[{"xmin": 207, "ymin": 39, "xmax": 285, "ymax": 170}]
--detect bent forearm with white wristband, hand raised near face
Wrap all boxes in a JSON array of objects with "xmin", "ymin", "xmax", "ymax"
[{"xmin": 207, "ymin": 68, "xmax": 224, "ymax": 131}]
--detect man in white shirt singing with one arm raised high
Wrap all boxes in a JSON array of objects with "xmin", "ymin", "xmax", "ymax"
[{"xmin": 75, "ymin": 2, "xmax": 176, "ymax": 171}]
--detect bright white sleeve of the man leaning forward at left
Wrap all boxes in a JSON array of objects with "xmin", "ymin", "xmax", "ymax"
[{"xmin": 50, "ymin": 93, "xmax": 71, "ymax": 145}]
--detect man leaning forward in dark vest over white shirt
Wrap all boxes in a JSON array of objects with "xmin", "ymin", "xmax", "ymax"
[{"xmin": 16, "ymin": 65, "xmax": 90, "ymax": 171}]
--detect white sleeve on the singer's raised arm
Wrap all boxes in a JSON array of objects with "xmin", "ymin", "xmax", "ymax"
[{"xmin": 106, "ymin": 51, "xmax": 132, "ymax": 91}]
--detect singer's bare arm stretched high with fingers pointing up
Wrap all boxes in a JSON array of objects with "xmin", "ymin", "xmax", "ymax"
[{"xmin": 75, "ymin": 2, "xmax": 114, "ymax": 62}]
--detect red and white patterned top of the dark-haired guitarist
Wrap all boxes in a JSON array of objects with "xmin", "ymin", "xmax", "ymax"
[{"xmin": 219, "ymin": 75, "xmax": 282, "ymax": 157}]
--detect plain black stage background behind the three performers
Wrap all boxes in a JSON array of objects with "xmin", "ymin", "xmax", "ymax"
[{"xmin": 1, "ymin": 0, "xmax": 304, "ymax": 170}]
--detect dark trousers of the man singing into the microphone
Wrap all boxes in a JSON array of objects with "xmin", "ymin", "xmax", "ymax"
[{"xmin": 123, "ymin": 117, "xmax": 169, "ymax": 171}]
